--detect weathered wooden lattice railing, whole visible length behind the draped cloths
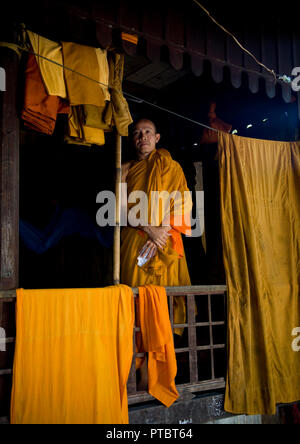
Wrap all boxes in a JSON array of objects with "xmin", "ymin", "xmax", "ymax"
[{"xmin": 0, "ymin": 285, "xmax": 226, "ymax": 417}]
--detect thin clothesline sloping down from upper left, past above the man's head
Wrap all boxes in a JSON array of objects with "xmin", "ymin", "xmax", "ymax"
[{"xmin": 2, "ymin": 42, "xmax": 220, "ymax": 132}]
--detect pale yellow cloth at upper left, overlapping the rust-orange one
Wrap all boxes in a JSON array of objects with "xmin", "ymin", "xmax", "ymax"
[{"xmin": 27, "ymin": 30, "xmax": 67, "ymax": 99}]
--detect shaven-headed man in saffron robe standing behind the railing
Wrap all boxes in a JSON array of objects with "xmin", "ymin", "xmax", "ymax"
[{"xmin": 121, "ymin": 119, "xmax": 192, "ymax": 334}]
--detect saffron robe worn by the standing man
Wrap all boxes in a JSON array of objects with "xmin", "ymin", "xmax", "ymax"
[{"xmin": 121, "ymin": 149, "xmax": 192, "ymax": 334}]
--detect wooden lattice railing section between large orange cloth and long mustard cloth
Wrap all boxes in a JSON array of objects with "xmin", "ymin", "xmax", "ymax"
[{"xmin": 127, "ymin": 286, "xmax": 226, "ymax": 404}]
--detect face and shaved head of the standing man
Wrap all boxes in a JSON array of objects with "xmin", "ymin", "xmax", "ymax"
[{"xmin": 133, "ymin": 120, "xmax": 160, "ymax": 160}]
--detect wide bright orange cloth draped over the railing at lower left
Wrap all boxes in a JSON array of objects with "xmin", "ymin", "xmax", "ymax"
[{"xmin": 11, "ymin": 285, "xmax": 134, "ymax": 424}]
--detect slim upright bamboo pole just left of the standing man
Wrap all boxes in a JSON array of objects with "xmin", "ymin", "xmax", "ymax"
[{"xmin": 113, "ymin": 133, "xmax": 122, "ymax": 285}]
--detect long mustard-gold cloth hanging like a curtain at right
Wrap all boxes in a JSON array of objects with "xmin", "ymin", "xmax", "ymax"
[{"xmin": 219, "ymin": 133, "xmax": 300, "ymax": 414}]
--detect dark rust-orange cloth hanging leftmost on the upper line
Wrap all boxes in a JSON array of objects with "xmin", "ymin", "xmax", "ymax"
[{"xmin": 21, "ymin": 54, "xmax": 70, "ymax": 135}]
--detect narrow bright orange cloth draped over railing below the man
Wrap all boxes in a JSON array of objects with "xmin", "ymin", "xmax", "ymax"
[{"xmin": 138, "ymin": 285, "xmax": 179, "ymax": 407}]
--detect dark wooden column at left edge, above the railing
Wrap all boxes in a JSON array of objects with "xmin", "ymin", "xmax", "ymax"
[{"xmin": 0, "ymin": 47, "xmax": 19, "ymax": 290}]
